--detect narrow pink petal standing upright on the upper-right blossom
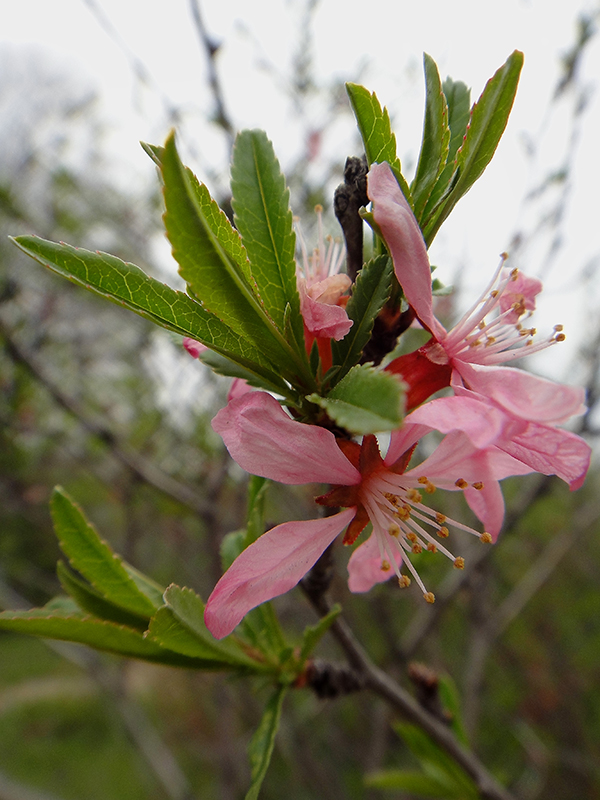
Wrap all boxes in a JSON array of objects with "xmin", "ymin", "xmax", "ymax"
[{"xmin": 367, "ymin": 163, "xmax": 446, "ymax": 339}]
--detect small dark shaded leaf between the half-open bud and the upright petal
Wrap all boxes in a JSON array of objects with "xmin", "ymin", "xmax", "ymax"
[{"xmin": 331, "ymin": 255, "xmax": 394, "ymax": 383}]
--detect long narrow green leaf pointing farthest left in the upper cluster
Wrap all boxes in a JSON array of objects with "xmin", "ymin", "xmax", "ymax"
[{"xmin": 13, "ymin": 236, "xmax": 272, "ymax": 376}]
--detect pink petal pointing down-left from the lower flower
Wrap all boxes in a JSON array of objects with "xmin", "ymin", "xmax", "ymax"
[{"xmin": 204, "ymin": 508, "xmax": 356, "ymax": 639}]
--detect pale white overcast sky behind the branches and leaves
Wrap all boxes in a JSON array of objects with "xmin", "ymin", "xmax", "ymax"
[{"xmin": 0, "ymin": 0, "xmax": 600, "ymax": 380}]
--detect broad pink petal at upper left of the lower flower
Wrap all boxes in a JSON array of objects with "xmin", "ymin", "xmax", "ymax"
[{"xmin": 212, "ymin": 392, "xmax": 360, "ymax": 486}]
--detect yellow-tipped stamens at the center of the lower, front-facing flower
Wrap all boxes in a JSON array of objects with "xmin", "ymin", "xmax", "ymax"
[{"xmin": 360, "ymin": 469, "xmax": 492, "ymax": 603}]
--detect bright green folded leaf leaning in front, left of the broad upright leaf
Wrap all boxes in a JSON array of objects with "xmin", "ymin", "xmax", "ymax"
[{"xmin": 161, "ymin": 134, "xmax": 308, "ymax": 386}]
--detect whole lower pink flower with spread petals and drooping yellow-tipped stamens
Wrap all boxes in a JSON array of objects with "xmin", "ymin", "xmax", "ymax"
[{"xmin": 205, "ymin": 392, "xmax": 531, "ymax": 638}]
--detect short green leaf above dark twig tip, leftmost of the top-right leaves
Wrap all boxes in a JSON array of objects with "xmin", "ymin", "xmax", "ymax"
[{"xmin": 346, "ymin": 83, "xmax": 413, "ymax": 207}]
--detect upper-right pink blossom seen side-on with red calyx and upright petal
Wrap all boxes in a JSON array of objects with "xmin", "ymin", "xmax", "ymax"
[{"xmin": 368, "ymin": 164, "xmax": 589, "ymax": 487}]
